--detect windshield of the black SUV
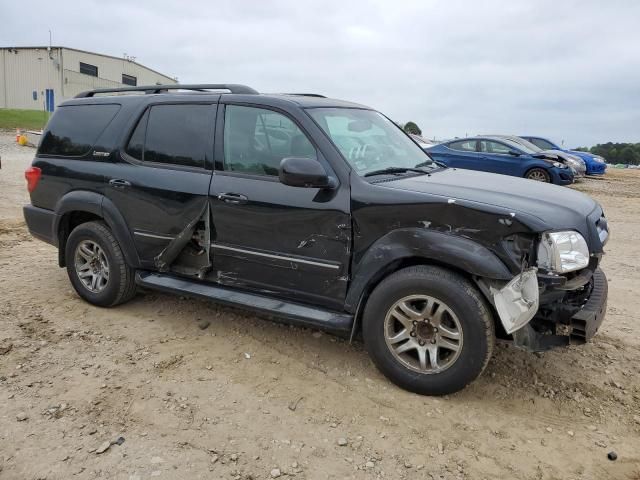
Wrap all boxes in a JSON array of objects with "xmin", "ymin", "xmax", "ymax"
[{"xmin": 307, "ymin": 108, "xmax": 436, "ymax": 176}]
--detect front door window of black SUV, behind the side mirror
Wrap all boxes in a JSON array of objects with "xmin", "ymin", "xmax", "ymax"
[{"xmin": 224, "ymin": 105, "xmax": 316, "ymax": 175}]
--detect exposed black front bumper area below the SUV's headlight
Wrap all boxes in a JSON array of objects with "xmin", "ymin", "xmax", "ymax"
[{"xmin": 513, "ymin": 268, "xmax": 609, "ymax": 352}]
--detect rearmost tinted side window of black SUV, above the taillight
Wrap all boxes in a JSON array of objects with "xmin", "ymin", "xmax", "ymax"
[{"xmin": 38, "ymin": 104, "xmax": 120, "ymax": 157}]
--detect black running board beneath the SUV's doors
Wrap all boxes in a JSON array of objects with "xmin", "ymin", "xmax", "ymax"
[{"xmin": 136, "ymin": 271, "xmax": 353, "ymax": 336}]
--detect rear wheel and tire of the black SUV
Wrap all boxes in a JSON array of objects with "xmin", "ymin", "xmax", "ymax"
[{"xmin": 65, "ymin": 222, "xmax": 136, "ymax": 307}]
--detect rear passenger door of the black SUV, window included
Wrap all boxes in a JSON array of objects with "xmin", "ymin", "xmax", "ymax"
[{"xmin": 107, "ymin": 102, "xmax": 216, "ymax": 267}]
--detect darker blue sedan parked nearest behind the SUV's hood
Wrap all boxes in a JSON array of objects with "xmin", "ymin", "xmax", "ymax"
[{"xmin": 426, "ymin": 136, "xmax": 573, "ymax": 185}]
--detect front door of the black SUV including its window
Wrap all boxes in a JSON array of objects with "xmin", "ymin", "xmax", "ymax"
[{"xmin": 210, "ymin": 105, "xmax": 351, "ymax": 308}]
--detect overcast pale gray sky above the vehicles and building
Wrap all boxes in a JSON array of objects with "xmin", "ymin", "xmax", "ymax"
[{"xmin": 0, "ymin": 0, "xmax": 640, "ymax": 147}]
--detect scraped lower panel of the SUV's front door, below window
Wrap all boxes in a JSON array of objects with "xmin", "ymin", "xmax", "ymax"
[{"xmin": 209, "ymin": 174, "xmax": 351, "ymax": 307}]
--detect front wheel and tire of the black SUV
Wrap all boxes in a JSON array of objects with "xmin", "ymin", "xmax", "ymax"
[{"xmin": 362, "ymin": 265, "xmax": 495, "ymax": 395}]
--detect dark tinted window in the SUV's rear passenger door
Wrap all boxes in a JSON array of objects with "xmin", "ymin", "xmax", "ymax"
[{"xmin": 126, "ymin": 105, "xmax": 213, "ymax": 168}]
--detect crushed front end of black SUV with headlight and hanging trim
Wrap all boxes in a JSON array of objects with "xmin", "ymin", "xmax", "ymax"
[{"xmin": 485, "ymin": 207, "xmax": 609, "ymax": 352}]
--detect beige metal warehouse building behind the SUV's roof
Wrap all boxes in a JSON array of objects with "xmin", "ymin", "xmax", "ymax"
[{"xmin": 0, "ymin": 47, "xmax": 177, "ymax": 112}]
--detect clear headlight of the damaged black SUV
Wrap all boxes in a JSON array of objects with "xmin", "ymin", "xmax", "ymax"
[{"xmin": 538, "ymin": 231, "xmax": 589, "ymax": 273}]
